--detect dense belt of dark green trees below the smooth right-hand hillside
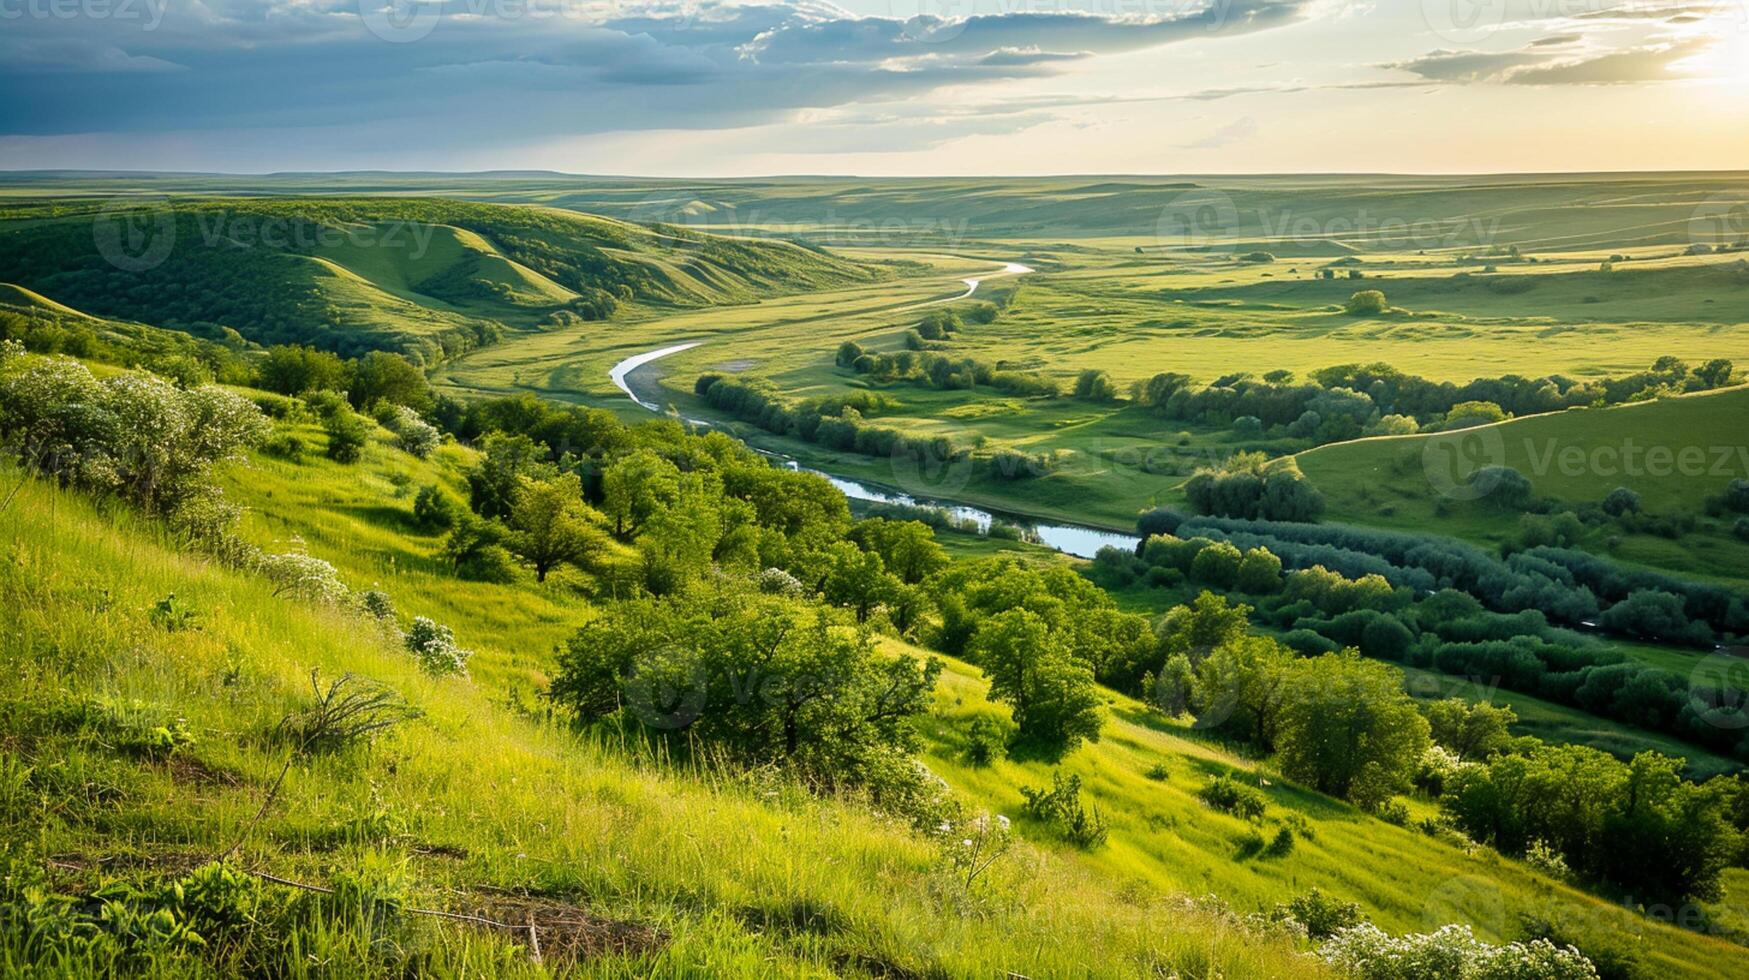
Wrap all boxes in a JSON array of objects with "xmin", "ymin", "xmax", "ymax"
[{"xmin": 1119, "ymin": 513, "xmax": 1749, "ymax": 753}]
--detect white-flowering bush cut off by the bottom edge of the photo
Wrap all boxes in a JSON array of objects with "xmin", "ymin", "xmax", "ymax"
[{"xmin": 1319, "ymin": 922, "xmax": 1597, "ymax": 980}]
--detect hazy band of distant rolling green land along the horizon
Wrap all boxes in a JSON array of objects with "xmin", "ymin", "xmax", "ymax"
[{"xmin": 13, "ymin": 172, "xmax": 1749, "ymax": 245}]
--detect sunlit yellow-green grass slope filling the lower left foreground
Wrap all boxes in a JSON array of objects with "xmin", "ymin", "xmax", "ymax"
[{"xmin": 0, "ymin": 458, "xmax": 1319, "ymax": 977}]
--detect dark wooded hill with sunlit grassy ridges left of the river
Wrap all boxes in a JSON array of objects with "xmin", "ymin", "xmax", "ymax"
[{"xmin": 0, "ymin": 198, "xmax": 878, "ymax": 361}]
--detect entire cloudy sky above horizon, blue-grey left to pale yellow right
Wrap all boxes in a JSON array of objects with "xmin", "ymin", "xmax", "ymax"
[{"xmin": 0, "ymin": 0, "xmax": 1749, "ymax": 177}]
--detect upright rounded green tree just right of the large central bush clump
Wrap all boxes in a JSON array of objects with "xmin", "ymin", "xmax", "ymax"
[{"xmin": 971, "ymin": 609, "xmax": 1100, "ymax": 751}]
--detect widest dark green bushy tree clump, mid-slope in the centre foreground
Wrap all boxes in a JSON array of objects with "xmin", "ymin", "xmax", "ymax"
[{"xmin": 551, "ymin": 588, "xmax": 941, "ymax": 796}]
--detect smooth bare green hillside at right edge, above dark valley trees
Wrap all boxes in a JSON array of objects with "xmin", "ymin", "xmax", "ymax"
[{"xmin": 1294, "ymin": 387, "xmax": 1749, "ymax": 578}]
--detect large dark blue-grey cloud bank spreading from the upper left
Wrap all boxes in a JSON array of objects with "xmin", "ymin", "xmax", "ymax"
[{"xmin": 0, "ymin": 0, "xmax": 1317, "ymax": 151}]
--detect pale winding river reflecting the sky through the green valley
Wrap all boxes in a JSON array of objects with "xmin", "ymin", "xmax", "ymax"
[{"xmin": 607, "ymin": 263, "xmax": 1137, "ymax": 558}]
